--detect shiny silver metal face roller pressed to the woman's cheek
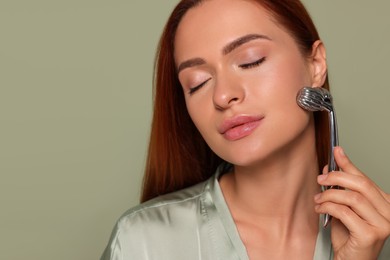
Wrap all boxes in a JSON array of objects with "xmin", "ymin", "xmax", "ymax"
[{"xmin": 297, "ymin": 87, "xmax": 339, "ymax": 227}]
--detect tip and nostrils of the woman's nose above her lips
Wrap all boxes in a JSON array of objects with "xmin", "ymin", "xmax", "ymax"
[{"xmin": 213, "ymin": 74, "xmax": 245, "ymax": 110}]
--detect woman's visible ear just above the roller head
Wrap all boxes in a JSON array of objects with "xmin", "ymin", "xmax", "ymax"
[{"xmin": 309, "ymin": 40, "xmax": 328, "ymax": 87}]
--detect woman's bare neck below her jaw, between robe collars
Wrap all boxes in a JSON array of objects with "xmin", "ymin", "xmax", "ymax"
[{"xmin": 221, "ymin": 125, "xmax": 320, "ymax": 242}]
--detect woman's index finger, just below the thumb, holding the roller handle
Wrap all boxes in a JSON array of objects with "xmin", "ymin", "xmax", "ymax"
[{"xmin": 317, "ymin": 173, "xmax": 390, "ymax": 221}]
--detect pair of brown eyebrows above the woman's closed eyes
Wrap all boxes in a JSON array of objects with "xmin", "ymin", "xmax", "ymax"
[{"xmin": 177, "ymin": 34, "xmax": 271, "ymax": 74}]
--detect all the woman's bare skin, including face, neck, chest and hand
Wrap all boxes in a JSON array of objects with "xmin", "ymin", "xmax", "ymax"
[{"xmin": 174, "ymin": 0, "xmax": 390, "ymax": 259}]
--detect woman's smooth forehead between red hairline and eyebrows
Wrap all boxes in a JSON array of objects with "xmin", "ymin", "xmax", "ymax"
[{"xmin": 174, "ymin": 0, "xmax": 287, "ymax": 60}]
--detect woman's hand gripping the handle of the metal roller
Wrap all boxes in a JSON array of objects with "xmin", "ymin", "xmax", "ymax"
[{"xmin": 315, "ymin": 147, "xmax": 390, "ymax": 260}]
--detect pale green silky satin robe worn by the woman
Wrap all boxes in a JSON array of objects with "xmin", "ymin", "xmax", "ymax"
[{"xmin": 101, "ymin": 164, "xmax": 390, "ymax": 260}]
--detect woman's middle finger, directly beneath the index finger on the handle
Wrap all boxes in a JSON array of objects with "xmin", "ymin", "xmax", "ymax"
[{"xmin": 315, "ymin": 189, "xmax": 389, "ymax": 227}]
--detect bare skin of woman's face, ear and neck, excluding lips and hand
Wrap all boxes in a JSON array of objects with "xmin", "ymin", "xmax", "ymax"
[{"xmin": 175, "ymin": 1, "xmax": 326, "ymax": 259}]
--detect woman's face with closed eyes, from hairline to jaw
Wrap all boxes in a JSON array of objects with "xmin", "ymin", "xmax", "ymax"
[{"xmin": 174, "ymin": 0, "xmax": 323, "ymax": 166}]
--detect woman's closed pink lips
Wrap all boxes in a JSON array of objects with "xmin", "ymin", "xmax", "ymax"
[{"xmin": 218, "ymin": 115, "xmax": 263, "ymax": 141}]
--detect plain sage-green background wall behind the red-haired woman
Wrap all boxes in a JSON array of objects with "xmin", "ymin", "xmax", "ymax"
[{"xmin": 0, "ymin": 0, "xmax": 390, "ymax": 260}]
